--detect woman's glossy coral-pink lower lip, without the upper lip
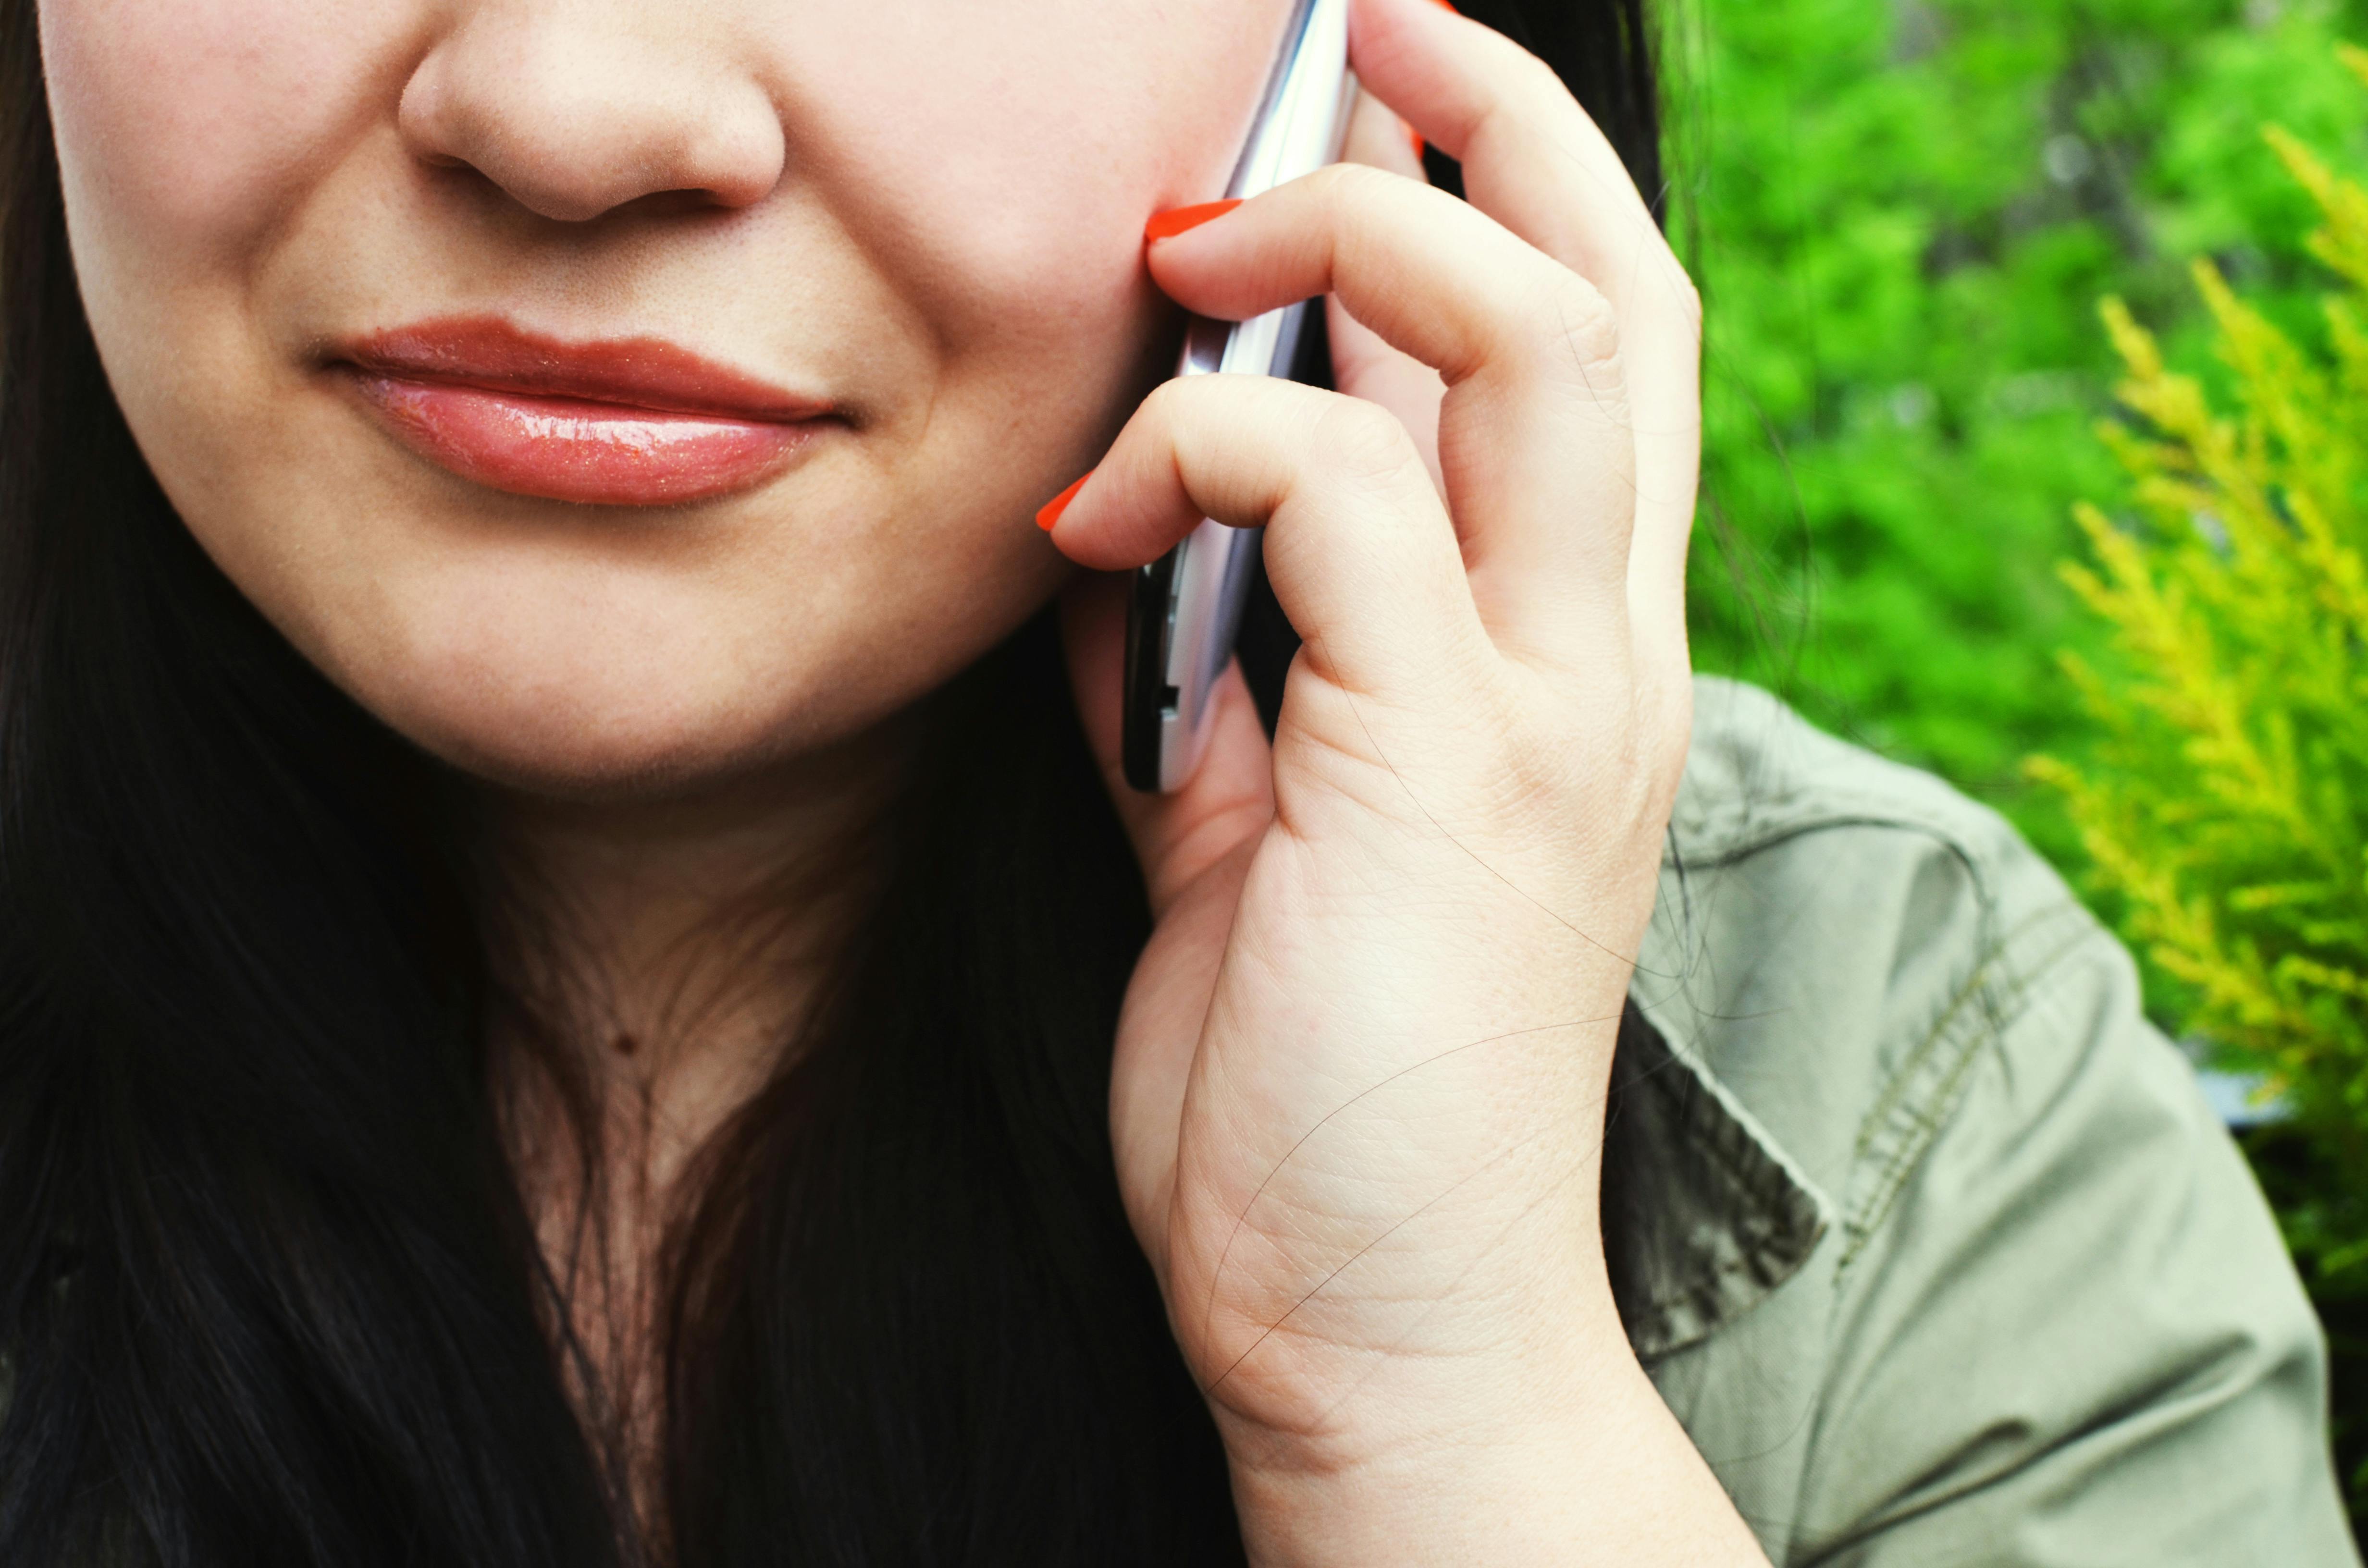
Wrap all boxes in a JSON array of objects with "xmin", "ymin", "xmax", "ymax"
[{"xmin": 353, "ymin": 372, "xmax": 819, "ymax": 507}]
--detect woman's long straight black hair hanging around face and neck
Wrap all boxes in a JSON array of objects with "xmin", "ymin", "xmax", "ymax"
[{"xmin": 0, "ymin": 0, "xmax": 1660, "ymax": 1568}]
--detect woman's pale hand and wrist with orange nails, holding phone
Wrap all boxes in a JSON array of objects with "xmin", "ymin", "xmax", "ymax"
[{"xmin": 1054, "ymin": 0, "xmax": 1752, "ymax": 1563}]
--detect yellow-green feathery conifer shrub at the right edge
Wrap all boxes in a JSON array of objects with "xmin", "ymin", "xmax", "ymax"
[{"xmin": 2029, "ymin": 50, "xmax": 2368, "ymax": 1293}]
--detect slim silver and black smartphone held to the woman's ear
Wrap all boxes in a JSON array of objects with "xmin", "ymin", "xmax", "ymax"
[{"xmin": 1120, "ymin": 0, "xmax": 1357, "ymax": 791}]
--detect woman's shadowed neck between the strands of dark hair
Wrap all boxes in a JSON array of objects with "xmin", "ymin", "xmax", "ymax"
[{"xmin": 490, "ymin": 723, "xmax": 916, "ymax": 1525}]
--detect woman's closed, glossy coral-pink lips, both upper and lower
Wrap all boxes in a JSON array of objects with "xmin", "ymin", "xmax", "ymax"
[{"xmin": 334, "ymin": 318, "xmax": 834, "ymax": 507}]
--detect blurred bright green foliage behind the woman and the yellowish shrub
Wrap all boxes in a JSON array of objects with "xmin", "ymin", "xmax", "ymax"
[{"xmin": 1662, "ymin": 0, "xmax": 2368, "ymax": 1525}]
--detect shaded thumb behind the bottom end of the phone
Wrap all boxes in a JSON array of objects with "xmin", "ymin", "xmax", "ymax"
[{"xmin": 1061, "ymin": 571, "xmax": 1274, "ymax": 919}]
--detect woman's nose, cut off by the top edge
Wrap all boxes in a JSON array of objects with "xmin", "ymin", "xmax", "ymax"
[{"xmin": 398, "ymin": 0, "xmax": 784, "ymax": 222}]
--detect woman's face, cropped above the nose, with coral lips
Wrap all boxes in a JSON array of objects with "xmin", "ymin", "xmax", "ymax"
[{"xmin": 40, "ymin": 0, "xmax": 1286, "ymax": 796}]
